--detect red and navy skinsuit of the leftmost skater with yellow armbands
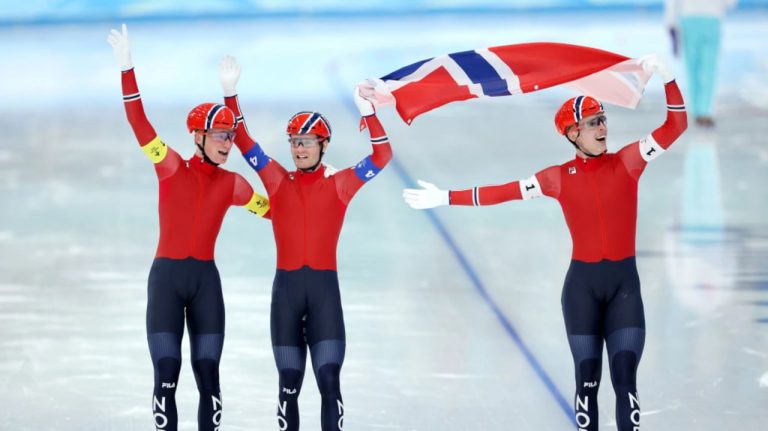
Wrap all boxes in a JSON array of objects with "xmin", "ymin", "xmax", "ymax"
[{"xmin": 122, "ymin": 69, "xmax": 268, "ymax": 431}]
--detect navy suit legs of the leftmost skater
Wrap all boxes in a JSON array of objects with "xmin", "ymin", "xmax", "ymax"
[{"xmin": 147, "ymin": 258, "xmax": 224, "ymax": 431}]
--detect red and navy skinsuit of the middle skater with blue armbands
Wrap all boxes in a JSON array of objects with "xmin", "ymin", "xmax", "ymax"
[{"xmin": 225, "ymin": 96, "xmax": 392, "ymax": 431}]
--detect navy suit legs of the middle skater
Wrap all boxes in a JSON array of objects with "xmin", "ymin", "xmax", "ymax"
[{"xmin": 270, "ymin": 266, "xmax": 346, "ymax": 431}]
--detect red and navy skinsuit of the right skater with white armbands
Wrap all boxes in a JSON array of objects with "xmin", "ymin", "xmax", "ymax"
[{"xmin": 450, "ymin": 81, "xmax": 687, "ymax": 431}]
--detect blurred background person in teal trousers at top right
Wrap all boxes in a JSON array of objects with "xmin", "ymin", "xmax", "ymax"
[{"xmin": 664, "ymin": 0, "xmax": 736, "ymax": 127}]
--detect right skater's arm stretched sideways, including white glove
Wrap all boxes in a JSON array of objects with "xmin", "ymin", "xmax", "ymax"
[{"xmin": 403, "ymin": 166, "xmax": 560, "ymax": 209}]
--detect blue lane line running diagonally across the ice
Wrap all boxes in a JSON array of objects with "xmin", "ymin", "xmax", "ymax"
[{"xmin": 328, "ymin": 68, "xmax": 576, "ymax": 424}]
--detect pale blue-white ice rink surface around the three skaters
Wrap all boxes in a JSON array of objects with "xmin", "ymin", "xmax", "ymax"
[{"xmin": 0, "ymin": 10, "xmax": 768, "ymax": 431}]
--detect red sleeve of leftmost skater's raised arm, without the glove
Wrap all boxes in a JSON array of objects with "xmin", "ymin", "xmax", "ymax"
[{"xmin": 121, "ymin": 69, "xmax": 182, "ymax": 179}]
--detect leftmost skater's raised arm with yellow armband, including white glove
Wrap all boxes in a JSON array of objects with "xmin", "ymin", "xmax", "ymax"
[{"xmin": 107, "ymin": 24, "xmax": 181, "ymax": 179}]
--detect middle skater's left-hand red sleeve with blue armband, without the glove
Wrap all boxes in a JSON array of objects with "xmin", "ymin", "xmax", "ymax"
[{"xmin": 224, "ymin": 96, "xmax": 287, "ymax": 196}]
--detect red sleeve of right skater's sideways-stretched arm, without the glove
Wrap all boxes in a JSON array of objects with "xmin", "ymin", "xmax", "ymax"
[{"xmin": 448, "ymin": 166, "xmax": 560, "ymax": 206}]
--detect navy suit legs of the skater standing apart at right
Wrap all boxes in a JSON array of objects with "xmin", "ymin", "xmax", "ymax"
[{"xmin": 562, "ymin": 257, "xmax": 645, "ymax": 431}]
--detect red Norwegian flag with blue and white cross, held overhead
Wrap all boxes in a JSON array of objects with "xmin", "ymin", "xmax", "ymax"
[{"xmin": 358, "ymin": 42, "xmax": 651, "ymax": 124}]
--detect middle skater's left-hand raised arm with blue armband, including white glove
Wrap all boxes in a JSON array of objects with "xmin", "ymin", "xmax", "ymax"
[{"xmin": 219, "ymin": 56, "xmax": 287, "ymax": 194}]
